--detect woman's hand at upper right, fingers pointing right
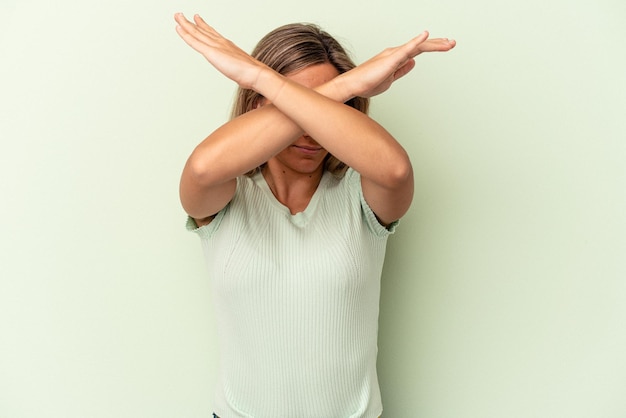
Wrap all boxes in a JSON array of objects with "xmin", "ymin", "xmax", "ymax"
[{"xmin": 337, "ymin": 32, "xmax": 456, "ymax": 97}]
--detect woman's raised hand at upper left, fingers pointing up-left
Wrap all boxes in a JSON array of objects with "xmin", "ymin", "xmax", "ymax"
[{"xmin": 174, "ymin": 13, "xmax": 269, "ymax": 89}]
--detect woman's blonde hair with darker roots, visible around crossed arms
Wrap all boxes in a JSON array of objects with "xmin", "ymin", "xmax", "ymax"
[{"xmin": 231, "ymin": 23, "xmax": 369, "ymax": 177}]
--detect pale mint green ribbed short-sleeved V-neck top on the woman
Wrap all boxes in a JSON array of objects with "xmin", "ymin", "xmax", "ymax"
[{"xmin": 188, "ymin": 169, "xmax": 395, "ymax": 418}]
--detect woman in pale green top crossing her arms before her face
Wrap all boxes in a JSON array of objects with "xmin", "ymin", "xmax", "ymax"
[{"xmin": 175, "ymin": 14, "xmax": 455, "ymax": 418}]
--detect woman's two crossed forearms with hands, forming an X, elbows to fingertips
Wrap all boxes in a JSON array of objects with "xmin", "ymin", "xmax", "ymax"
[{"xmin": 175, "ymin": 13, "xmax": 456, "ymax": 187}]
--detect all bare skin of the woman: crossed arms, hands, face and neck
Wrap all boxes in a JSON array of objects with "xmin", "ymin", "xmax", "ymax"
[{"xmin": 175, "ymin": 13, "xmax": 456, "ymax": 225}]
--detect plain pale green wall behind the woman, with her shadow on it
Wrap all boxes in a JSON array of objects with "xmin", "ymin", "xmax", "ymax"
[{"xmin": 0, "ymin": 0, "xmax": 626, "ymax": 418}]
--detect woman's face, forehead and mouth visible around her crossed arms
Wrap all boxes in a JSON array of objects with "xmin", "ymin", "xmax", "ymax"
[{"xmin": 268, "ymin": 63, "xmax": 339, "ymax": 174}]
